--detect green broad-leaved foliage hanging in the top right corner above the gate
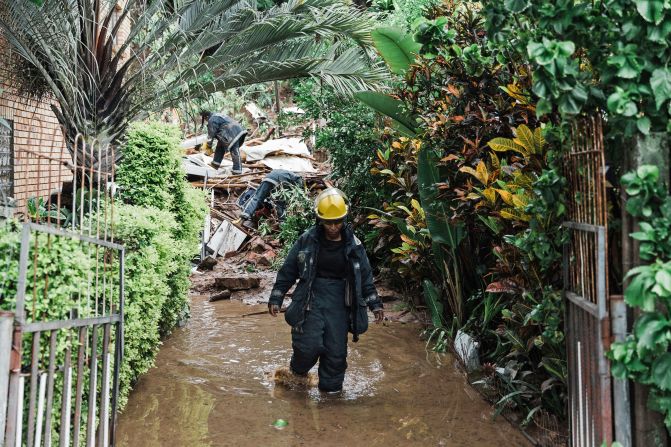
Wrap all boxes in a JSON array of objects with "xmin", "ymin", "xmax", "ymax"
[{"xmin": 484, "ymin": 0, "xmax": 671, "ymax": 135}]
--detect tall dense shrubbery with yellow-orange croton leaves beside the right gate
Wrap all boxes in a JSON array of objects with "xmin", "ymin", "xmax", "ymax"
[{"xmin": 364, "ymin": 5, "xmax": 566, "ymax": 423}]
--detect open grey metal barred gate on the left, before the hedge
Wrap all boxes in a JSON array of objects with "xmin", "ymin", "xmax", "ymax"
[{"xmin": 0, "ymin": 136, "xmax": 124, "ymax": 447}]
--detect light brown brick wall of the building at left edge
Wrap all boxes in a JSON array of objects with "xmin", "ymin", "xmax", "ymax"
[{"xmin": 0, "ymin": 34, "xmax": 72, "ymax": 212}]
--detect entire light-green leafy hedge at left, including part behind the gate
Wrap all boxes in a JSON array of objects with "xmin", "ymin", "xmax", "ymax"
[{"xmin": 0, "ymin": 124, "xmax": 206, "ymax": 424}]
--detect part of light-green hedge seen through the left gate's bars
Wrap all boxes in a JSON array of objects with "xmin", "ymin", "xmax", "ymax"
[{"xmin": 0, "ymin": 220, "xmax": 107, "ymax": 443}]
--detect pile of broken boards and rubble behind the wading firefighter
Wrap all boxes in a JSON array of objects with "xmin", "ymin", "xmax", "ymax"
[{"xmin": 181, "ymin": 109, "xmax": 329, "ymax": 301}]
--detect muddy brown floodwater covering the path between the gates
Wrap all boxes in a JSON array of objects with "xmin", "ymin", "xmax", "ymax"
[{"xmin": 117, "ymin": 296, "xmax": 530, "ymax": 447}]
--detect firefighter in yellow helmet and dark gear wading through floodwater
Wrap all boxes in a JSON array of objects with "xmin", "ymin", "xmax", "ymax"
[{"xmin": 268, "ymin": 188, "xmax": 384, "ymax": 392}]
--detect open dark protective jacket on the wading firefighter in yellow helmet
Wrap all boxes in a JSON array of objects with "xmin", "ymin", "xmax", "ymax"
[{"xmin": 268, "ymin": 225, "xmax": 382, "ymax": 341}]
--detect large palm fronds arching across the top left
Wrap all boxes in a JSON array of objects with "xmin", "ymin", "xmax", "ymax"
[{"xmin": 0, "ymin": 0, "xmax": 387, "ymax": 170}]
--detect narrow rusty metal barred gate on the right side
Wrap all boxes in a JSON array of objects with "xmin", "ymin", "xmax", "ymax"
[{"xmin": 564, "ymin": 115, "xmax": 613, "ymax": 447}]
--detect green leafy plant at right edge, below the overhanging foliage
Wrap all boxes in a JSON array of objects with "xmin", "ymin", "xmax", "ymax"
[{"xmin": 608, "ymin": 165, "xmax": 671, "ymax": 431}]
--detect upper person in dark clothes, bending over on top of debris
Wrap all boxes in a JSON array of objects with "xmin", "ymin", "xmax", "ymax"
[{"xmin": 200, "ymin": 110, "xmax": 247, "ymax": 174}]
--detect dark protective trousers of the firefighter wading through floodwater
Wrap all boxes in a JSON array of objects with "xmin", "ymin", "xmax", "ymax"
[{"xmin": 291, "ymin": 278, "xmax": 348, "ymax": 391}]
